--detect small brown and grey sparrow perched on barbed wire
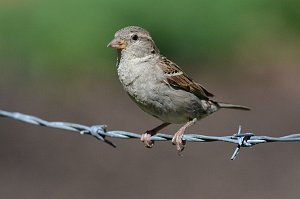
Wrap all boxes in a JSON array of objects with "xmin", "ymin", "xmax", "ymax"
[{"xmin": 107, "ymin": 26, "xmax": 250, "ymax": 152}]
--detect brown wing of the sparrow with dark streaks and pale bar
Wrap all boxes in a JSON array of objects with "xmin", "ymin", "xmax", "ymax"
[{"xmin": 159, "ymin": 57, "xmax": 214, "ymax": 99}]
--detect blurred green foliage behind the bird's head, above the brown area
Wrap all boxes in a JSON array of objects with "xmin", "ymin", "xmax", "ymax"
[{"xmin": 0, "ymin": 0, "xmax": 300, "ymax": 73}]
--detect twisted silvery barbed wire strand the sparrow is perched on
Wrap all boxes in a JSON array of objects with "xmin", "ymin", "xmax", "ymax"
[{"xmin": 0, "ymin": 110, "xmax": 300, "ymax": 160}]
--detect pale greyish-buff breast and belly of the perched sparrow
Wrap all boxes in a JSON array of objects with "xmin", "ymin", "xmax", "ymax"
[{"xmin": 118, "ymin": 57, "xmax": 213, "ymax": 123}]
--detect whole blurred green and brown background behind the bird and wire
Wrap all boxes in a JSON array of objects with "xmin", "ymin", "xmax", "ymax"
[{"xmin": 0, "ymin": 0, "xmax": 300, "ymax": 199}]
